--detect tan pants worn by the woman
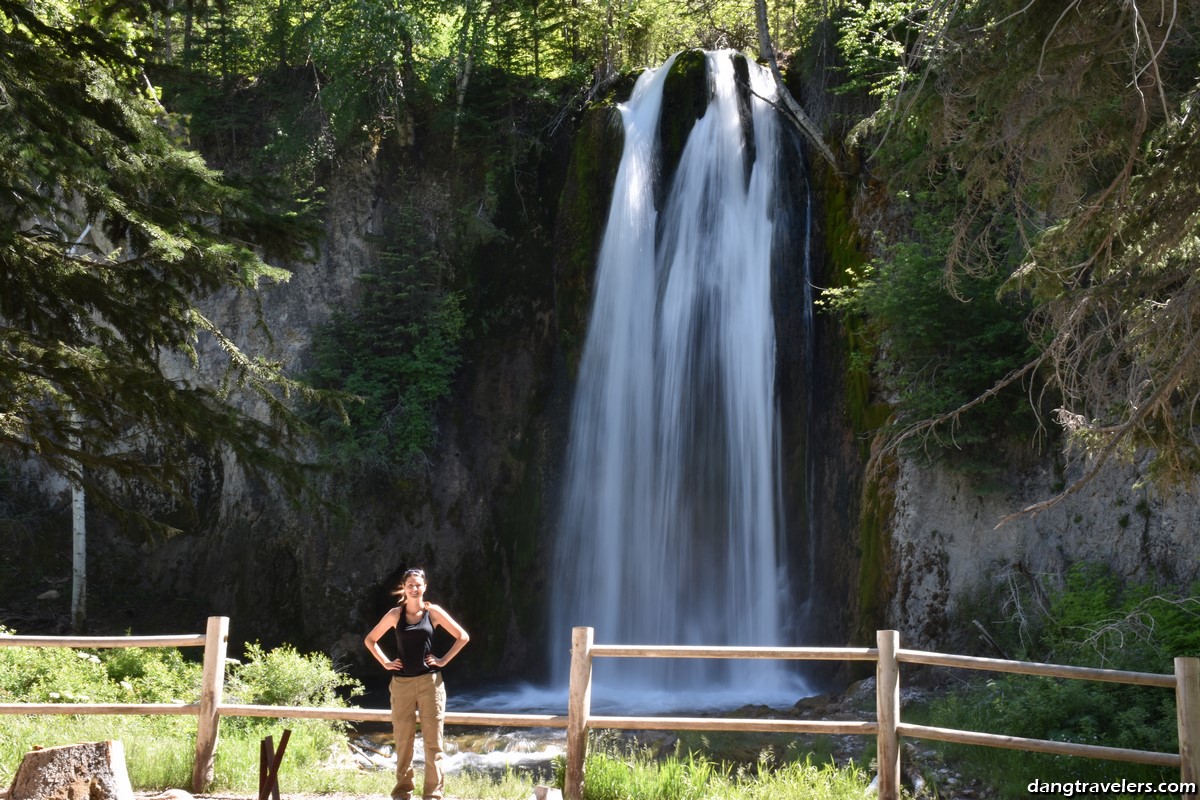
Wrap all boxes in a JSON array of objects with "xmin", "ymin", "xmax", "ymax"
[{"xmin": 390, "ymin": 672, "xmax": 446, "ymax": 800}]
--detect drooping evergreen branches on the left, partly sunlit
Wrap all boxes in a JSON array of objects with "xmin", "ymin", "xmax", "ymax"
[{"xmin": 0, "ymin": 0, "xmax": 324, "ymax": 525}]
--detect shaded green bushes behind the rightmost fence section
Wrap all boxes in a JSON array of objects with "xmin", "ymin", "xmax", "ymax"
[{"xmin": 905, "ymin": 564, "xmax": 1200, "ymax": 798}]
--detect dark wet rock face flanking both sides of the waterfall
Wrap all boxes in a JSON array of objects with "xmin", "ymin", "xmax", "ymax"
[{"xmin": 106, "ymin": 53, "xmax": 860, "ymax": 680}]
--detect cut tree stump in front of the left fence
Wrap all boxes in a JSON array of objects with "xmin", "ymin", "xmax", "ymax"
[{"xmin": 8, "ymin": 741, "xmax": 133, "ymax": 800}]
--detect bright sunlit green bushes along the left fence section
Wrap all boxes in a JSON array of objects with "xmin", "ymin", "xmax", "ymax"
[{"xmin": 0, "ymin": 628, "xmax": 364, "ymax": 793}]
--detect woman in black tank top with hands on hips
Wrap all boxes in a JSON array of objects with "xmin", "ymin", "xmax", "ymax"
[{"xmin": 364, "ymin": 570, "xmax": 470, "ymax": 800}]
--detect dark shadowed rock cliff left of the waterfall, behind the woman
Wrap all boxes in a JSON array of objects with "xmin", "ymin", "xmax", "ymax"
[{"xmin": 0, "ymin": 126, "xmax": 571, "ymax": 681}]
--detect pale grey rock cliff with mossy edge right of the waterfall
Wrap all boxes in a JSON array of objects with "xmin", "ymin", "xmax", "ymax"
[{"xmin": 790, "ymin": 21, "xmax": 1200, "ymax": 655}]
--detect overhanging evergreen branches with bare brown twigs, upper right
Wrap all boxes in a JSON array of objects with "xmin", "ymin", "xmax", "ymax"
[{"xmin": 841, "ymin": 0, "xmax": 1200, "ymax": 507}]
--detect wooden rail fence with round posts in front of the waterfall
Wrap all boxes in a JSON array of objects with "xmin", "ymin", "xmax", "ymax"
[{"xmin": 0, "ymin": 616, "xmax": 1200, "ymax": 800}]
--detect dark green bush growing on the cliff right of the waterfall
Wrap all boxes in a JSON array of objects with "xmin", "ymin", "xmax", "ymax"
[{"xmin": 823, "ymin": 200, "xmax": 1037, "ymax": 483}]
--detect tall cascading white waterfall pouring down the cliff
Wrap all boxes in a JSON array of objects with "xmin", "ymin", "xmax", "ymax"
[{"xmin": 550, "ymin": 52, "xmax": 811, "ymax": 702}]
